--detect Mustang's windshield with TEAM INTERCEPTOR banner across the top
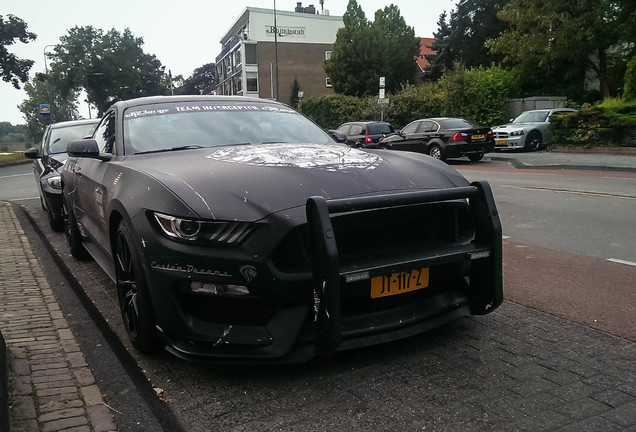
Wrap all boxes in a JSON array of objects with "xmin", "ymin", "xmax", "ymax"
[{"xmin": 124, "ymin": 101, "xmax": 333, "ymax": 154}]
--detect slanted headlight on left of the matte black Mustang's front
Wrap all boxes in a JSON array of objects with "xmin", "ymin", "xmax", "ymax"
[{"xmin": 154, "ymin": 213, "xmax": 254, "ymax": 246}]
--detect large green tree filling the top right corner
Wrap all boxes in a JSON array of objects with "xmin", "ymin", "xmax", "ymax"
[{"xmin": 487, "ymin": 0, "xmax": 636, "ymax": 97}]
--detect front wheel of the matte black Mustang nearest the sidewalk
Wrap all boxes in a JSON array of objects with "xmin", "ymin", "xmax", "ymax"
[{"xmin": 113, "ymin": 222, "xmax": 163, "ymax": 354}]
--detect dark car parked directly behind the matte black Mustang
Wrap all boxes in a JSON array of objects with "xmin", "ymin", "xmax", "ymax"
[{"xmin": 24, "ymin": 119, "xmax": 99, "ymax": 231}]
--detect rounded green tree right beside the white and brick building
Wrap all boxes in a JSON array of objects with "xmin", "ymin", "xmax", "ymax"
[{"xmin": 324, "ymin": 0, "xmax": 419, "ymax": 96}]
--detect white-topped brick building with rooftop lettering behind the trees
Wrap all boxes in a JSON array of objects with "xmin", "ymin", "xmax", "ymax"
[{"xmin": 216, "ymin": 3, "xmax": 344, "ymax": 103}]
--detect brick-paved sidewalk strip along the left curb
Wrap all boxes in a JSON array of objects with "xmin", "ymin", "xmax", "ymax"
[{"xmin": 0, "ymin": 202, "xmax": 117, "ymax": 432}]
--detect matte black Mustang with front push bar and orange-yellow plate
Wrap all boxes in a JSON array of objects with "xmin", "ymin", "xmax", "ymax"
[{"xmin": 62, "ymin": 96, "xmax": 502, "ymax": 363}]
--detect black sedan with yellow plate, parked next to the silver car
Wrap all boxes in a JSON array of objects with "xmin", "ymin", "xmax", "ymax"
[{"xmin": 379, "ymin": 117, "xmax": 495, "ymax": 162}]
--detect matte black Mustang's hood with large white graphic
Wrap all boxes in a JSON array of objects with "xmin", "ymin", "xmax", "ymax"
[{"xmin": 127, "ymin": 144, "xmax": 468, "ymax": 221}]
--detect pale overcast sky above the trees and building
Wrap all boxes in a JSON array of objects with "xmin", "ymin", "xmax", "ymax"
[{"xmin": 0, "ymin": 0, "xmax": 458, "ymax": 125}]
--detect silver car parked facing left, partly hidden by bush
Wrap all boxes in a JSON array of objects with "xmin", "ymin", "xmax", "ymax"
[{"xmin": 492, "ymin": 108, "xmax": 576, "ymax": 151}]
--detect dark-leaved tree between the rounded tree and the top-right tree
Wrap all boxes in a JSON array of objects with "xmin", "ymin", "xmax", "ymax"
[{"xmin": 424, "ymin": 0, "xmax": 508, "ymax": 80}]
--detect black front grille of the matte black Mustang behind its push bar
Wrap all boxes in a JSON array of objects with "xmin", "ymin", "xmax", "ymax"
[{"xmin": 274, "ymin": 201, "xmax": 474, "ymax": 273}]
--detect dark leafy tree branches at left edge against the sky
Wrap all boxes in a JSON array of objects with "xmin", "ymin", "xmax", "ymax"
[{"xmin": 0, "ymin": 15, "xmax": 37, "ymax": 89}]
